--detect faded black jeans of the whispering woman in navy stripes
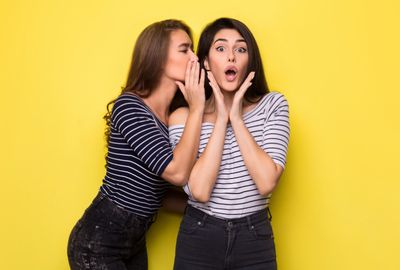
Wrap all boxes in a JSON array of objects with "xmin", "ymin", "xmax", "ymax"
[{"xmin": 68, "ymin": 192, "xmax": 153, "ymax": 270}]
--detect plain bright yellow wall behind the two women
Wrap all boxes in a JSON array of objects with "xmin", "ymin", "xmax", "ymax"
[{"xmin": 0, "ymin": 0, "xmax": 400, "ymax": 270}]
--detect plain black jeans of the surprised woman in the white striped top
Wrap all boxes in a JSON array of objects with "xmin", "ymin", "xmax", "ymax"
[{"xmin": 174, "ymin": 206, "xmax": 277, "ymax": 270}]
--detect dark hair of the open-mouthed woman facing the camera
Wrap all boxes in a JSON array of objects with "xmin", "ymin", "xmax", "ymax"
[{"xmin": 170, "ymin": 18, "xmax": 269, "ymax": 111}]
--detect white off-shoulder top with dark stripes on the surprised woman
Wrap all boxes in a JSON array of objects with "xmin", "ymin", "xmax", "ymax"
[{"xmin": 169, "ymin": 92, "xmax": 290, "ymax": 219}]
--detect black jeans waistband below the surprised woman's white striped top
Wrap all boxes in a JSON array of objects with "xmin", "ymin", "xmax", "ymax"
[{"xmin": 185, "ymin": 205, "xmax": 272, "ymax": 226}]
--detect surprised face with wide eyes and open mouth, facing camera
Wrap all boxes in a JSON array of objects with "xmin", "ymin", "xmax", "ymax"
[{"xmin": 204, "ymin": 29, "xmax": 249, "ymax": 92}]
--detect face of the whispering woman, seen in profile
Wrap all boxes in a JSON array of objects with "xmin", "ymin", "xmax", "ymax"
[{"xmin": 164, "ymin": 30, "xmax": 198, "ymax": 81}]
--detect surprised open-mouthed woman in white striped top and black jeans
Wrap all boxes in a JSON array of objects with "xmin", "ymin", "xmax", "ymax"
[{"xmin": 169, "ymin": 18, "xmax": 289, "ymax": 270}]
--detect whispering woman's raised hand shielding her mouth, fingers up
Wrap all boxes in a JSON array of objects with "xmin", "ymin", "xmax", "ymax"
[{"xmin": 175, "ymin": 60, "xmax": 205, "ymax": 111}]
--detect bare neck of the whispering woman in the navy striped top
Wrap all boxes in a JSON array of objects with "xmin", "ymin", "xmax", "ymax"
[{"xmin": 143, "ymin": 75, "xmax": 177, "ymax": 124}]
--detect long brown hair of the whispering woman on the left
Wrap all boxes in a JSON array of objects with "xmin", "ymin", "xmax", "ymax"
[{"xmin": 103, "ymin": 20, "xmax": 192, "ymax": 149}]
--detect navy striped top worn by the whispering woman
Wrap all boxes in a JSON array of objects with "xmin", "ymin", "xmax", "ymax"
[{"xmin": 100, "ymin": 94, "xmax": 172, "ymax": 217}]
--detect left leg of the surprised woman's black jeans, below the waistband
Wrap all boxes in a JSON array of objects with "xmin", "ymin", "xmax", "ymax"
[{"xmin": 174, "ymin": 215, "xmax": 226, "ymax": 270}]
